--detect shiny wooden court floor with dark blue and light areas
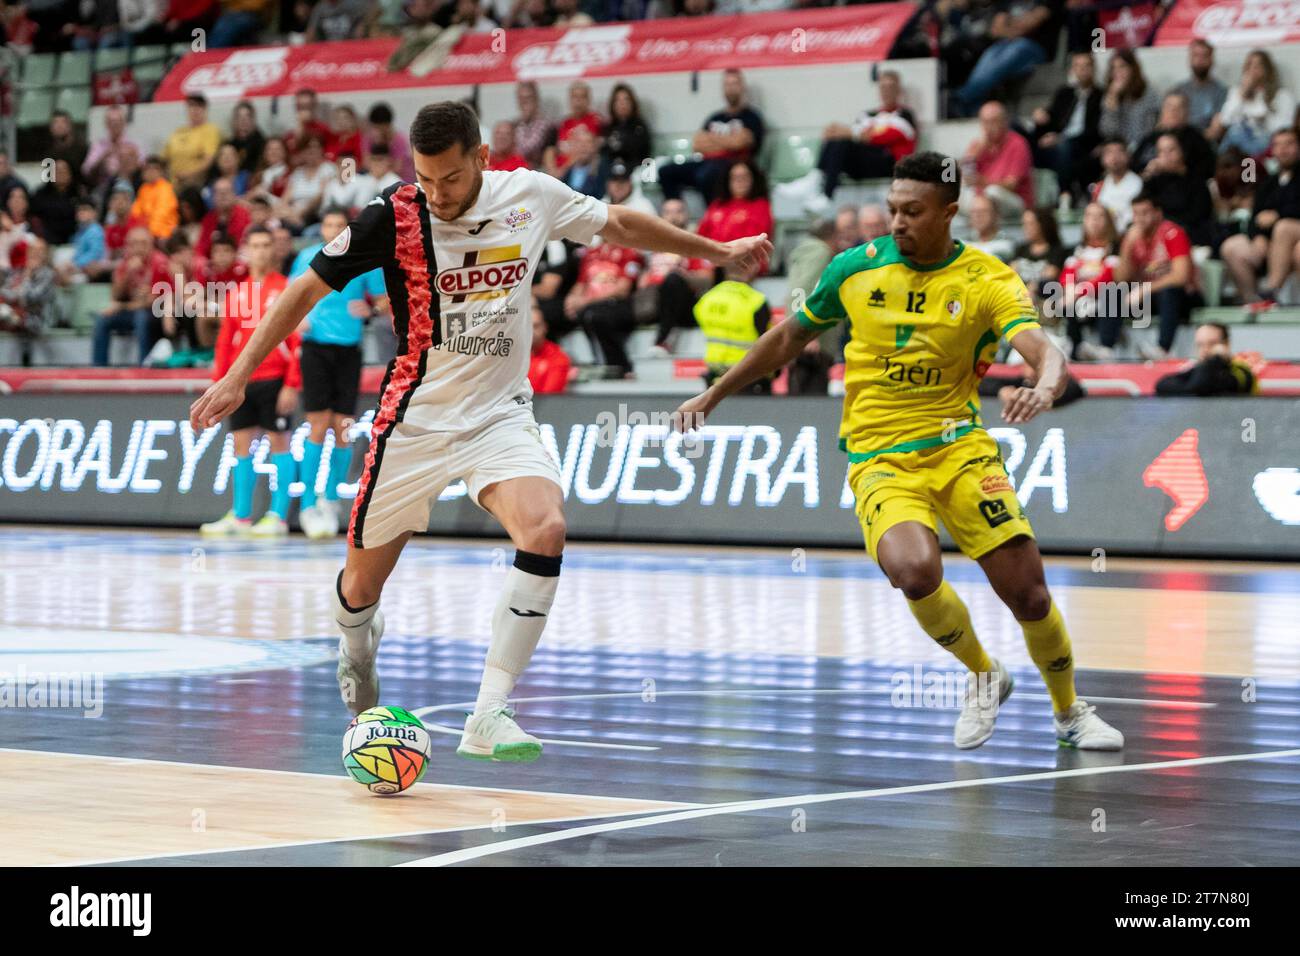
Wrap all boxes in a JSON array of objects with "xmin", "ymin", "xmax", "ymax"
[{"xmin": 0, "ymin": 527, "xmax": 1300, "ymax": 865}]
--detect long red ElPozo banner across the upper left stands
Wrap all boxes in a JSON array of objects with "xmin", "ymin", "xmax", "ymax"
[{"xmin": 153, "ymin": 3, "xmax": 917, "ymax": 101}]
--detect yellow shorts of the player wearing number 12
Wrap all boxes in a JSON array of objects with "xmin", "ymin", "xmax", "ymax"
[{"xmin": 849, "ymin": 431, "xmax": 1034, "ymax": 561}]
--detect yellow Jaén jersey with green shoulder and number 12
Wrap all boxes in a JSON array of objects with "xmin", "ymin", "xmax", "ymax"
[{"xmin": 797, "ymin": 235, "xmax": 1040, "ymax": 462}]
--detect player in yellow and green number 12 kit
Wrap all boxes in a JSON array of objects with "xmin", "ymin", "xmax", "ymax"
[{"xmin": 677, "ymin": 152, "xmax": 1123, "ymax": 750}]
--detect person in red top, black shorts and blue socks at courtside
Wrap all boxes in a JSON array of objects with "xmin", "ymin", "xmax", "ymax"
[{"xmin": 200, "ymin": 226, "xmax": 303, "ymax": 537}]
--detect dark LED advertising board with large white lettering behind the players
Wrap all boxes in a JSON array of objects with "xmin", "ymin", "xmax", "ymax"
[{"xmin": 0, "ymin": 394, "xmax": 1300, "ymax": 559}]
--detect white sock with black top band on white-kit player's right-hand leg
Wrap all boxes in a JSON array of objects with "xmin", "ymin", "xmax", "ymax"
[{"xmin": 475, "ymin": 551, "xmax": 560, "ymax": 714}]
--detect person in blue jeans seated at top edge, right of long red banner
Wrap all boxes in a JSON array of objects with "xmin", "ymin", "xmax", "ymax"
[{"xmin": 953, "ymin": 0, "xmax": 1065, "ymax": 116}]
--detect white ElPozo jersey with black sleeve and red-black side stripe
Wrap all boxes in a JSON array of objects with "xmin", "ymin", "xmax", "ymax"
[{"xmin": 312, "ymin": 169, "xmax": 608, "ymax": 433}]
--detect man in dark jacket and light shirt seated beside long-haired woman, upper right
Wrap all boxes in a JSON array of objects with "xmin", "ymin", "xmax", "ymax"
[{"xmin": 1031, "ymin": 52, "xmax": 1101, "ymax": 204}]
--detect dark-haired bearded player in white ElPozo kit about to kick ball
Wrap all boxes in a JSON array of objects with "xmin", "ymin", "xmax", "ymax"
[{"xmin": 190, "ymin": 101, "xmax": 772, "ymax": 761}]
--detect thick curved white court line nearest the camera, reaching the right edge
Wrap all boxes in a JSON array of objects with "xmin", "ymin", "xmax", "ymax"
[{"xmin": 398, "ymin": 749, "xmax": 1300, "ymax": 866}]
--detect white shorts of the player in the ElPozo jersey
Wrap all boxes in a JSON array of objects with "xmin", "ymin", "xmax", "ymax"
[{"xmin": 347, "ymin": 406, "xmax": 560, "ymax": 548}]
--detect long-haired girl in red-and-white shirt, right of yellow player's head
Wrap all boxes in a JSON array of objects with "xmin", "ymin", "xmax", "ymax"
[{"xmin": 1052, "ymin": 203, "xmax": 1122, "ymax": 362}]
